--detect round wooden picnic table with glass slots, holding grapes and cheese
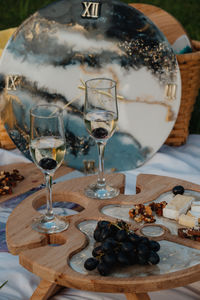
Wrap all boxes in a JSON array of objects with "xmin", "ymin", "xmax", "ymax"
[{"xmin": 6, "ymin": 174, "xmax": 200, "ymax": 300}]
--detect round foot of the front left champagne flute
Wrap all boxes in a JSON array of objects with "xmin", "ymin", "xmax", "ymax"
[{"xmin": 32, "ymin": 215, "xmax": 69, "ymax": 234}]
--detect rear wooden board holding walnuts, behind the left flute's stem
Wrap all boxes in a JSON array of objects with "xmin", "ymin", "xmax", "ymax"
[{"xmin": 0, "ymin": 163, "xmax": 73, "ymax": 203}]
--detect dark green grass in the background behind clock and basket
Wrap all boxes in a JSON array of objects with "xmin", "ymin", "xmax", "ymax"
[{"xmin": 0, "ymin": 0, "xmax": 200, "ymax": 134}]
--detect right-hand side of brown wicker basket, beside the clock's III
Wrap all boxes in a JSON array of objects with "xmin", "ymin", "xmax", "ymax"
[{"xmin": 165, "ymin": 41, "xmax": 200, "ymax": 146}]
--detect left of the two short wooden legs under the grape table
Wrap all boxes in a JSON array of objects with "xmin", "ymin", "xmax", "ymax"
[{"xmin": 30, "ymin": 280, "xmax": 63, "ymax": 300}]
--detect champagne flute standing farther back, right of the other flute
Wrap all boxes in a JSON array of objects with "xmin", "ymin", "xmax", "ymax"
[{"xmin": 84, "ymin": 78, "xmax": 119, "ymax": 199}]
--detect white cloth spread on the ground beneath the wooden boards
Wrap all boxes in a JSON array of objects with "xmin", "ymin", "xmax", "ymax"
[{"xmin": 0, "ymin": 135, "xmax": 200, "ymax": 300}]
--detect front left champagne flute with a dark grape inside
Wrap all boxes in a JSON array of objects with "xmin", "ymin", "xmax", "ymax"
[{"xmin": 29, "ymin": 104, "xmax": 68, "ymax": 233}]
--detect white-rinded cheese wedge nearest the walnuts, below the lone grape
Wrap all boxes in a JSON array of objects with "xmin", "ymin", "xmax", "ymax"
[{"xmin": 163, "ymin": 195, "xmax": 195, "ymax": 220}]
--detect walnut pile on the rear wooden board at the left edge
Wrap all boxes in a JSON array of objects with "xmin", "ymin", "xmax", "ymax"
[{"xmin": 0, "ymin": 169, "xmax": 24, "ymax": 196}]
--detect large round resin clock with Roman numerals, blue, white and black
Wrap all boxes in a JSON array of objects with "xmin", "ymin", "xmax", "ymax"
[{"xmin": 0, "ymin": 0, "xmax": 181, "ymax": 171}]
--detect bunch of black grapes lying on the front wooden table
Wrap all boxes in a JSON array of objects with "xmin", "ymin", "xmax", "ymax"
[{"xmin": 84, "ymin": 220, "xmax": 160, "ymax": 276}]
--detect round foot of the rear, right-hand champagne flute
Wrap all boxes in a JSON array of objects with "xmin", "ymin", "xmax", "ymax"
[{"xmin": 85, "ymin": 184, "xmax": 120, "ymax": 199}]
